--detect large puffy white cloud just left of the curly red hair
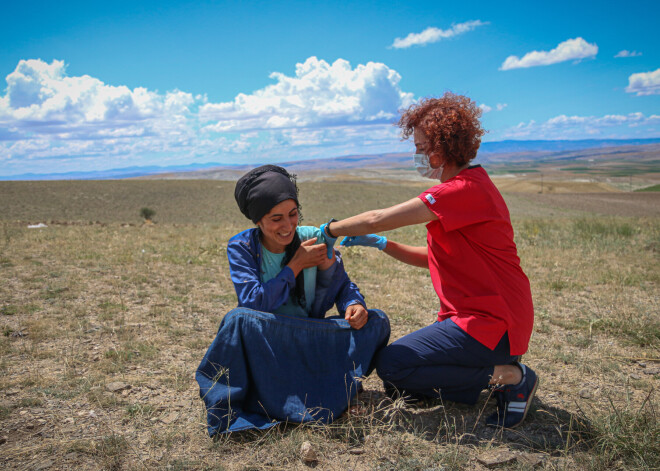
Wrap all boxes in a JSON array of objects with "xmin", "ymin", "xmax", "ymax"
[{"xmin": 199, "ymin": 57, "xmax": 413, "ymax": 132}]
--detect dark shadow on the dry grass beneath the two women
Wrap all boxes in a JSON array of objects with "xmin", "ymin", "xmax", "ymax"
[{"xmin": 218, "ymin": 391, "xmax": 590, "ymax": 455}]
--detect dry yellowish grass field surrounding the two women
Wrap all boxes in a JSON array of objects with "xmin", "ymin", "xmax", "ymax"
[{"xmin": 0, "ymin": 179, "xmax": 660, "ymax": 470}]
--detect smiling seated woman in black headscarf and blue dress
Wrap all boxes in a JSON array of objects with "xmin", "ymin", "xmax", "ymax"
[{"xmin": 196, "ymin": 165, "xmax": 390, "ymax": 436}]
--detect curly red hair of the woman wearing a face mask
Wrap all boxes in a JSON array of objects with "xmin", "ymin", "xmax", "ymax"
[{"xmin": 398, "ymin": 92, "xmax": 486, "ymax": 167}]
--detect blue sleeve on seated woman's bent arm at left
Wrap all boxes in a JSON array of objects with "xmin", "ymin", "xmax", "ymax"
[{"xmin": 227, "ymin": 240, "xmax": 296, "ymax": 312}]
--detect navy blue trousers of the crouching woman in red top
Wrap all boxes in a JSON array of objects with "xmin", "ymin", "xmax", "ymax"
[{"xmin": 376, "ymin": 319, "xmax": 517, "ymax": 404}]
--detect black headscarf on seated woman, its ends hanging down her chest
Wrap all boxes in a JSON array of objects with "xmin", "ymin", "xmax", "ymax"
[{"xmin": 234, "ymin": 165, "xmax": 306, "ymax": 307}]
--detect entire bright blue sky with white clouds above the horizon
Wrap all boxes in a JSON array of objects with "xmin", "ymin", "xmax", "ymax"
[{"xmin": 0, "ymin": 0, "xmax": 660, "ymax": 176}]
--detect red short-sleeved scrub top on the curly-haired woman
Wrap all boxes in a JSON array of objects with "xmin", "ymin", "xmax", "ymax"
[{"xmin": 419, "ymin": 166, "xmax": 534, "ymax": 355}]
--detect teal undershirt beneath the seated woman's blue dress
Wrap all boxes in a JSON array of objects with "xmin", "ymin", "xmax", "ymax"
[{"xmin": 261, "ymin": 226, "xmax": 321, "ymax": 317}]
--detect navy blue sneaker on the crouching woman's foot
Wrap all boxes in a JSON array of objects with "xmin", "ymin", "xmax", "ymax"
[{"xmin": 486, "ymin": 363, "xmax": 539, "ymax": 428}]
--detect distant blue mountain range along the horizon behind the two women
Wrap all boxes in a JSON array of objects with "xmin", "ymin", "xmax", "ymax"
[{"xmin": 0, "ymin": 138, "xmax": 660, "ymax": 180}]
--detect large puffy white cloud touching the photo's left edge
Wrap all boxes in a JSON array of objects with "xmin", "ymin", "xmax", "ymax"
[{"xmin": 0, "ymin": 59, "xmax": 195, "ymax": 139}]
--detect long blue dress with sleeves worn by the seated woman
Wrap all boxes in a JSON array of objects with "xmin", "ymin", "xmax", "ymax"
[{"xmin": 196, "ymin": 229, "xmax": 390, "ymax": 436}]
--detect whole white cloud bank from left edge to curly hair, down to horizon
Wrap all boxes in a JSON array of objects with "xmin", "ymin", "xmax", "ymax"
[{"xmin": 0, "ymin": 57, "xmax": 413, "ymax": 175}]
